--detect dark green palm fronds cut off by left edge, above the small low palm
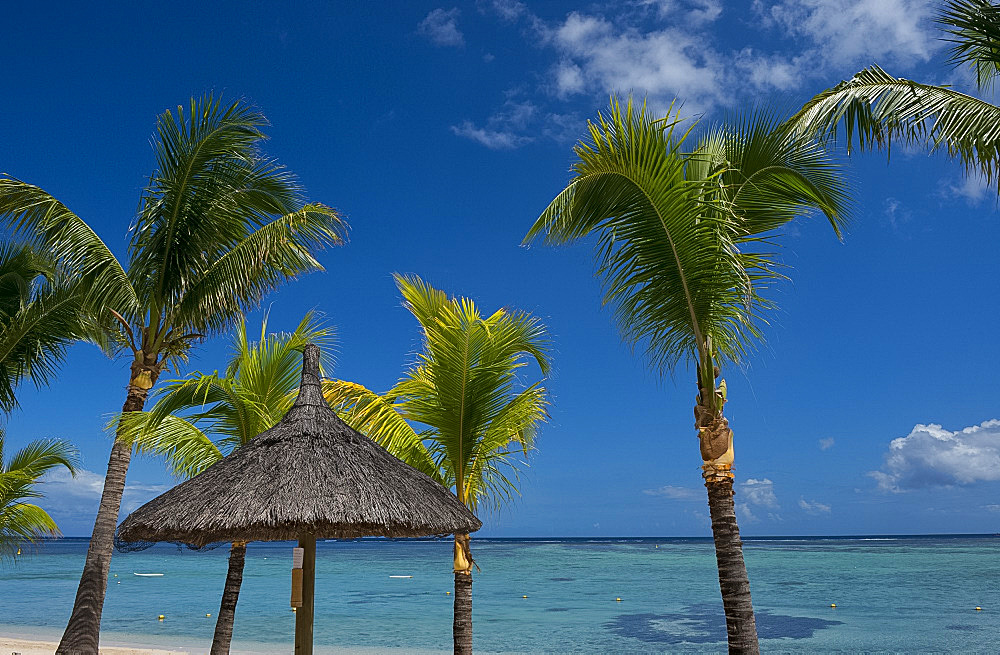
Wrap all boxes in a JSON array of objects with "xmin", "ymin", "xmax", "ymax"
[{"xmin": 0, "ymin": 242, "xmax": 92, "ymax": 413}]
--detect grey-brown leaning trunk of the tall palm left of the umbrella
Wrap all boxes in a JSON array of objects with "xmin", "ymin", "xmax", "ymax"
[{"xmin": 56, "ymin": 363, "xmax": 158, "ymax": 655}]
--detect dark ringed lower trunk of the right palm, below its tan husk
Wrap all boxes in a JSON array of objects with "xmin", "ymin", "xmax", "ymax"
[{"xmin": 705, "ymin": 477, "xmax": 760, "ymax": 654}]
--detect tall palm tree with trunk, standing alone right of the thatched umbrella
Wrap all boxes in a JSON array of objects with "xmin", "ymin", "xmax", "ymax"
[{"xmin": 525, "ymin": 100, "xmax": 846, "ymax": 653}]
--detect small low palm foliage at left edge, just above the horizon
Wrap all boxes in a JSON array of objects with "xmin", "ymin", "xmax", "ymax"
[{"xmin": 0, "ymin": 428, "xmax": 77, "ymax": 560}]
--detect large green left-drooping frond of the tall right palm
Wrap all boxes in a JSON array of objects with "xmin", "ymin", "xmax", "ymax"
[{"xmin": 525, "ymin": 100, "xmax": 755, "ymax": 370}]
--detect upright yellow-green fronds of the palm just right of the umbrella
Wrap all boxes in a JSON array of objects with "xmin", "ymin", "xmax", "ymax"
[{"xmin": 390, "ymin": 276, "xmax": 550, "ymax": 509}]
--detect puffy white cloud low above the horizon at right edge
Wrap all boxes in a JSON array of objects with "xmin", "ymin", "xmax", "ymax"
[{"xmin": 868, "ymin": 420, "xmax": 1000, "ymax": 492}]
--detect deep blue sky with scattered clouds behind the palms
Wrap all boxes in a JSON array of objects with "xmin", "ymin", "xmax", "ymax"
[{"xmin": 0, "ymin": 0, "xmax": 1000, "ymax": 536}]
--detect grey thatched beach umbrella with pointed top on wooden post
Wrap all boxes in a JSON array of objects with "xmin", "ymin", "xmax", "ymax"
[{"xmin": 117, "ymin": 345, "xmax": 482, "ymax": 654}]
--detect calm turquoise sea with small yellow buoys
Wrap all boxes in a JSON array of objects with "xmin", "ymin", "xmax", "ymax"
[{"xmin": 0, "ymin": 536, "xmax": 1000, "ymax": 653}]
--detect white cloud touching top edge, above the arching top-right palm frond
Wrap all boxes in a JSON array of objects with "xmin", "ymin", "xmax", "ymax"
[{"xmin": 754, "ymin": 0, "xmax": 937, "ymax": 68}]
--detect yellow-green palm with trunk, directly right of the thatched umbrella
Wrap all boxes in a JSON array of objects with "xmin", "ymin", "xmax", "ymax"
[{"xmin": 326, "ymin": 275, "xmax": 549, "ymax": 653}]
